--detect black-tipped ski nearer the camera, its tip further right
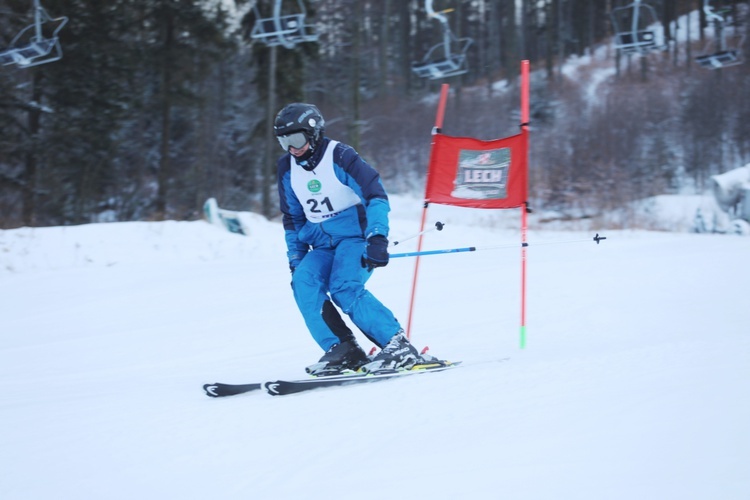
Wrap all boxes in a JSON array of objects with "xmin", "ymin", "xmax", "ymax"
[{"xmin": 263, "ymin": 361, "xmax": 461, "ymax": 396}]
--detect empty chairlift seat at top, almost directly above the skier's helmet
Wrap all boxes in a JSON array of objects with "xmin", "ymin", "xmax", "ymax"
[{"xmin": 250, "ymin": 0, "xmax": 318, "ymax": 49}]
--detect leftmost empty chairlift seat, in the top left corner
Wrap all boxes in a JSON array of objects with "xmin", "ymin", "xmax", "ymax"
[{"xmin": 0, "ymin": 0, "xmax": 68, "ymax": 68}]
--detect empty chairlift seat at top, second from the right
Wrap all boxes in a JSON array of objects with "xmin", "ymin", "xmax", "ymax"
[{"xmin": 610, "ymin": 0, "xmax": 665, "ymax": 54}]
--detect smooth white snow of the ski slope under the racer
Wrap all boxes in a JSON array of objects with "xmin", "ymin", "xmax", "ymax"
[{"xmin": 0, "ymin": 197, "xmax": 750, "ymax": 500}]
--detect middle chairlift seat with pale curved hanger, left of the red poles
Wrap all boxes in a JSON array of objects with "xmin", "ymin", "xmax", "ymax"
[{"xmin": 411, "ymin": 0, "xmax": 474, "ymax": 80}]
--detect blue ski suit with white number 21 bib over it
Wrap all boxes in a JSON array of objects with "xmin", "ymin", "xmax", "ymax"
[{"xmin": 277, "ymin": 137, "xmax": 401, "ymax": 351}]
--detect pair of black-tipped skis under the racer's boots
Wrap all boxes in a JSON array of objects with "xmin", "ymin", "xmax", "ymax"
[{"xmin": 203, "ymin": 360, "xmax": 461, "ymax": 398}]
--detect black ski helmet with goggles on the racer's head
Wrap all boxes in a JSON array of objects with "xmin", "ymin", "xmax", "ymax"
[{"xmin": 273, "ymin": 102, "xmax": 325, "ymax": 160}]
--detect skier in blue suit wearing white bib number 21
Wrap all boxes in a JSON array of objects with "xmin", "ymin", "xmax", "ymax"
[{"xmin": 274, "ymin": 103, "xmax": 421, "ymax": 375}]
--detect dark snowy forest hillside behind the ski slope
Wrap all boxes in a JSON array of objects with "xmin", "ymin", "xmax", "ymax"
[{"xmin": 0, "ymin": 0, "xmax": 750, "ymax": 228}]
